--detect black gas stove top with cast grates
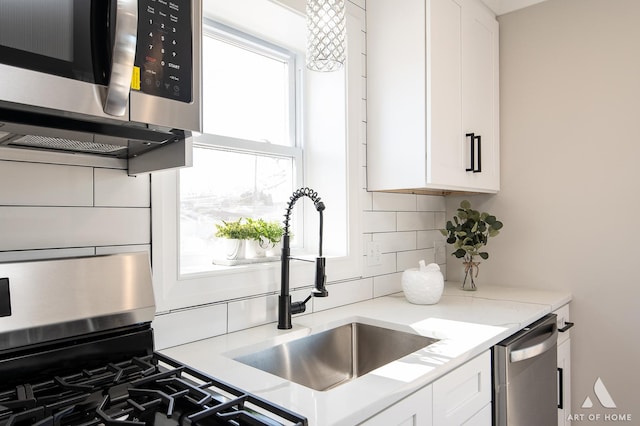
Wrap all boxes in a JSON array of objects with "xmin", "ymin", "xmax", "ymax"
[{"xmin": 0, "ymin": 353, "xmax": 307, "ymax": 426}]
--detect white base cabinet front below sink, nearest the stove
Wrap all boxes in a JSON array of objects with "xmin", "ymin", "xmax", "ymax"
[{"xmin": 361, "ymin": 386, "xmax": 432, "ymax": 426}]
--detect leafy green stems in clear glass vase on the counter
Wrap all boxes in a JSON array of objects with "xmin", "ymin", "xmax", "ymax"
[{"xmin": 440, "ymin": 200, "xmax": 503, "ymax": 290}]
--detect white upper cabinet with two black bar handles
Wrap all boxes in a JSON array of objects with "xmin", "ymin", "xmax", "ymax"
[{"xmin": 367, "ymin": 0, "xmax": 500, "ymax": 193}]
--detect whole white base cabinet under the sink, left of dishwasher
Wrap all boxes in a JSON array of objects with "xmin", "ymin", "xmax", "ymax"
[{"xmin": 362, "ymin": 350, "xmax": 492, "ymax": 426}]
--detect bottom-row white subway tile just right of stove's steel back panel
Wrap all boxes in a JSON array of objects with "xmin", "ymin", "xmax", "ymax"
[{"xmin": 152, "ymin": 304, "xmax": 227, "ymax": 350}]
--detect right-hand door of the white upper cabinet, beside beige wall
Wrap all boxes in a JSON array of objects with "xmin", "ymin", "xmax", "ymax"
[{"xmin": 461, "ymin": 0, "xmax": 500, "ymax": 191}]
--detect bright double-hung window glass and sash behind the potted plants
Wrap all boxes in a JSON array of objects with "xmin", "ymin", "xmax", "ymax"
[{"xmin": 179, "ymin": 20, "xmax": 303, "ymax": 274}]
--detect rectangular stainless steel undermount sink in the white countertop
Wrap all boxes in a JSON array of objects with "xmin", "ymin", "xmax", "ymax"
[{"xmin": 234, "ymin": 322, "xmax": 438, "ymax": 391}]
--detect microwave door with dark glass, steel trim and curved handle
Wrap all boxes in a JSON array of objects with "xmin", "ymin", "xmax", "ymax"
[{"xmin": 0, "ymin": 0, "xmax": 138, "ymax": 120}]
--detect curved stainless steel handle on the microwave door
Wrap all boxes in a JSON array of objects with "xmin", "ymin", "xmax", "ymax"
[{"xmin": 103, "ymin": 0, "xmax": 138, "ymax": 117}]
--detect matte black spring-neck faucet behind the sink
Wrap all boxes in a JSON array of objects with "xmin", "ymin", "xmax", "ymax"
[{"xmin": 278, "ymin": 188, "xmax": 329, "ymax": 330}]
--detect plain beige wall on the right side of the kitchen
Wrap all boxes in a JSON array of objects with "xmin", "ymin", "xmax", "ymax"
[{"xmin": 447, "ymin": 0, "xmax": 640, "ymax": 424}]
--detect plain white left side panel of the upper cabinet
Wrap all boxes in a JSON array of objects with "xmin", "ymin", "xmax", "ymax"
[{"xmin": 367, "ymin": 0, "xmax": 427, "ymax": 190}]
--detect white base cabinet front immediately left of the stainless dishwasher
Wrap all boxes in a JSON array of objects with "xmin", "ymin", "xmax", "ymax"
[{"xmin": 433, "ymin": 351, "xmax": 491, "ymax": 426}]
